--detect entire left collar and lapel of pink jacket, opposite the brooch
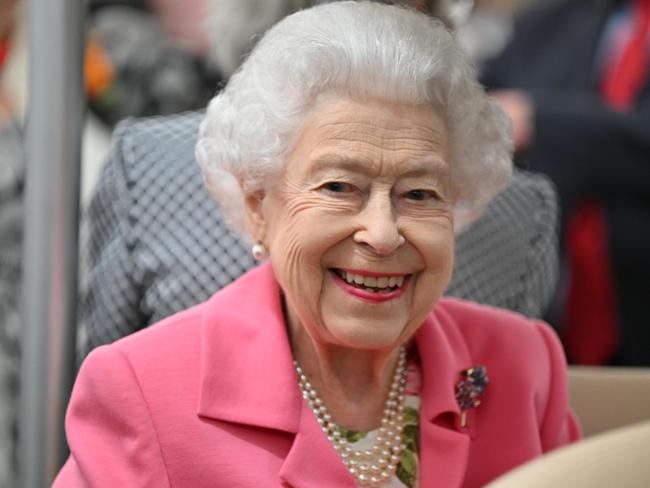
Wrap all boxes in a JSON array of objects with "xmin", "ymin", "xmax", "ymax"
[{"xmin": 197, "ymin": 263, "xmax": 354, "ymax": 488}]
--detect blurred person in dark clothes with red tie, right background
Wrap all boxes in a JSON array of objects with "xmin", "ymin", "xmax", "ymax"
[{"xmin": 484, "ymin": 0, "xmax": 650, "ymax": 366}]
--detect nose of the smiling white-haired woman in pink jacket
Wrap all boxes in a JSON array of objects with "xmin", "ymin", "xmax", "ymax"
[{"xmin": 354, "ymin": 194, "xmax": 405, "ymax": 256}]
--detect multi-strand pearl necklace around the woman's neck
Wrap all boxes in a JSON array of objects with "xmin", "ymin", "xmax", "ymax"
[{"xmin": 293, "ymin": 347, "xmax": 408, "ymax": 487}]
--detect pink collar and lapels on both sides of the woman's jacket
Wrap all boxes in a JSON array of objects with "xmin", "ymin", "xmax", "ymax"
[{"xmin": 198, "ymin": 263, "xmax": 472, "ymax": 487}]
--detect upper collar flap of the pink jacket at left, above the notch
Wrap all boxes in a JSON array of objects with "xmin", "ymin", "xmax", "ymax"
[{"xmin": 197, "ymin": 263, "xmax": 302, "ymax": 433}]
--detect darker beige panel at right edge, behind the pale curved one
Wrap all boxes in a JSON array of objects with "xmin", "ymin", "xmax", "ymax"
[{"xmin": 569, "ymin": 366, "xmax": 650, "ymax": 436}]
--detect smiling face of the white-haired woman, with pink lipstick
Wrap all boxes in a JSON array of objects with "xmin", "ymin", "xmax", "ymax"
[{"xmin": 248, "ymin": 100, "xmax": 454, "ymax": 349}]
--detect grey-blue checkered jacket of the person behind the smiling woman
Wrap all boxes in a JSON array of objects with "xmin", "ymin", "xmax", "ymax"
[{"xmin": 80, "ymin": 113, "xmax": 558, "ymax": 354}]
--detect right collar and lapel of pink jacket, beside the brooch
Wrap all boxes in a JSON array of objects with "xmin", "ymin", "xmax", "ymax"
[{"xmin": 416, "ymin": 313, "xmax": 476, "ymax": 487}]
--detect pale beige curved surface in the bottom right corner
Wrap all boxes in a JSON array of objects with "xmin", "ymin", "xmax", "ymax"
[{"xmin": 486, "ymin": 421, "xmax": 650, "ymax": 488}]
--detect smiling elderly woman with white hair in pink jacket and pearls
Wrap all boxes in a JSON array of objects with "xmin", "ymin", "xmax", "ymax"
[{"xmin": 55, "ymin": 2, "xmax": 579, "ymax": 488}]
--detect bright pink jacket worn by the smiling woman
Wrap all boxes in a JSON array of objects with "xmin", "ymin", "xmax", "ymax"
[{"xmin": 54, "ymin": 264, "xmax": 579, "ymax": 488}]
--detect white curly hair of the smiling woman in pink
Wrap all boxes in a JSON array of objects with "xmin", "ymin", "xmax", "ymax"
[{"xmin": 196, "ymin": 1, "xmax": 512, "ymax": 238}]
